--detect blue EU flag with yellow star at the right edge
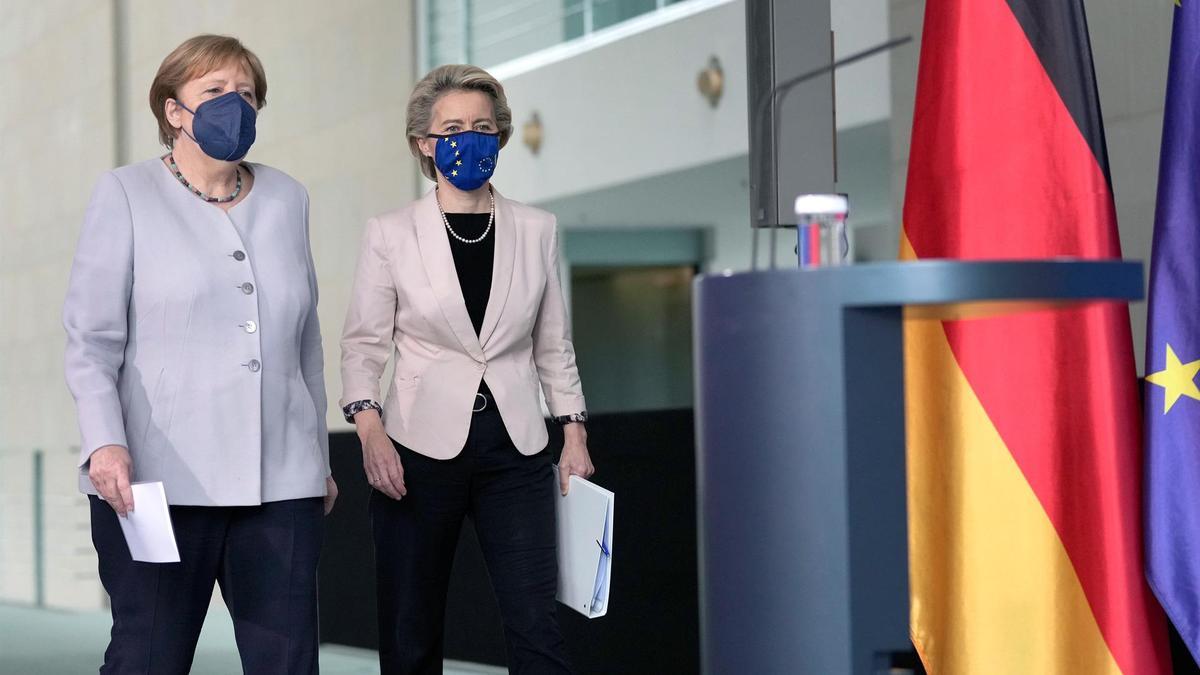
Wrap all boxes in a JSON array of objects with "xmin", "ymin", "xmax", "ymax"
[{"xmin": 1145, "ymin": 0, "xmax": 1200, "ymax": 658}]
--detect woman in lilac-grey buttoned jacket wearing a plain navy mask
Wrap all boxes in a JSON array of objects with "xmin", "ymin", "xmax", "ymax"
[{"xmin": 62, "ymin": 35, "xmax": 337, "ymax": 674}]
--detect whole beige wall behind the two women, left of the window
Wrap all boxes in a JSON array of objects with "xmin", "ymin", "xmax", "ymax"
[{"xmin": 0, "ymin": 0, "xmax": 416, "ymax": 608}]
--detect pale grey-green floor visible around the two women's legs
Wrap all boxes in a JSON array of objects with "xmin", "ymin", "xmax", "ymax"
[{"xmin": 0, "ymin": 602, "xmax": 504, "ymax": 675}]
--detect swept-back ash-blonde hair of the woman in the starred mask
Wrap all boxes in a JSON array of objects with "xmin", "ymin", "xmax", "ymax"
[{"xmin": 406, "ymin": 65, "xmax": 512, "ymax": 180}]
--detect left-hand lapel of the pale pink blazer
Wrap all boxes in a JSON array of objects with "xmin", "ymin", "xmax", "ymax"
[{"xmin": 414, "ymin": 190, "xmax": 484, "ymax": 360}]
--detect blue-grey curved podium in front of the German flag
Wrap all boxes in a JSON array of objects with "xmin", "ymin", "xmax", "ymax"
[{"xmin": 694, "ymin": 259, "xmax": 1142, "ymax": 675}]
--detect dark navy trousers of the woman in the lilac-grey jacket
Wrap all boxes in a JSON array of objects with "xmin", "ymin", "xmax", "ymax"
[{"xmin": 91, "ymin": 497, "xmax": 323, "ymax": 675}]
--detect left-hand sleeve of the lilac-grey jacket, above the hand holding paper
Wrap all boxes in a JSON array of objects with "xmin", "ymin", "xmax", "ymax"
[{"xmin": 62, "ymin": 173, "xmax": 133, "ymax": 466}]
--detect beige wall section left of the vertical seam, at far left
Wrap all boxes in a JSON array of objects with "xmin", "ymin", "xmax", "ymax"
[{"xmin": 0, "ymin": 1, "xmax": 116, "ymax": 607}]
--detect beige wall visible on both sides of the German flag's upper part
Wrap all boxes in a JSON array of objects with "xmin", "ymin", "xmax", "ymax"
[{"xmin": 889, "ymin": 0, "xmax": 1175, "ymax": 371}]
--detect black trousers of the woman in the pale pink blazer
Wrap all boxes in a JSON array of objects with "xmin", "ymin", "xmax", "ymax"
[{"xmin": 371, "ymin": 407, "xmax": 570, "ymax": 675}]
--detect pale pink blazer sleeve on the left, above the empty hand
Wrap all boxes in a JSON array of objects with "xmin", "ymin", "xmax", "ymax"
[{"xmin": 340, "ymin": 219, "xmax": 397, "ymax": 407}]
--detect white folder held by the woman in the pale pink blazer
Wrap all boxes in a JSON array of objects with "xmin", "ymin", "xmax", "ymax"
[{"xmin": 554, "ymin": 466, "xmax": 613, "ymax": 619}]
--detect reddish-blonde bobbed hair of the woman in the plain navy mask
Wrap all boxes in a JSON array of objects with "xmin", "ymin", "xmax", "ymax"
[{"xmin": 150, "ymin": 35, "xmax": 266, "ymax": 148}]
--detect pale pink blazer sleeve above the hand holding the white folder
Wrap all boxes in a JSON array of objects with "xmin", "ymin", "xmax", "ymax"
[{"xmin": 533, "ymin": 220, "xmax": 587, "ymax": 417}]
